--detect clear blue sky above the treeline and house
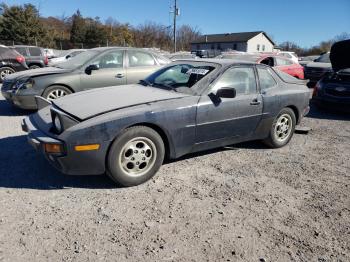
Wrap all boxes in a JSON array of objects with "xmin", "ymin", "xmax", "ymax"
[{"xmin": 0, "ymin": 0, "xmax": 350, "ymax": 47}]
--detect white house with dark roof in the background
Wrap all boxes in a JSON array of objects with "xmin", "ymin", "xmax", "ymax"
[{"xmin": 191, "ymin": 31, "xmax": 275, "ymax": 52}]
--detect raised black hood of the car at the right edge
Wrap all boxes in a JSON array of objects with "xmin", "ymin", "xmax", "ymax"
[{"xmin": 329, "ymin": 39, "xmax": 350, "ymax": 72}]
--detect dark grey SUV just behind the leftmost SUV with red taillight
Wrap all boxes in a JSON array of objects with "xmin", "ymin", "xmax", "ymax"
[{"xmin": 13, "ymin": 45, "xmax": 49, "ymax": 69}]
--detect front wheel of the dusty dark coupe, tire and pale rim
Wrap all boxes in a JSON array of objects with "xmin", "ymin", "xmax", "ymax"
[{"xmin": 107, "ymin": 126, "xmax": 165, "ymax": 187}]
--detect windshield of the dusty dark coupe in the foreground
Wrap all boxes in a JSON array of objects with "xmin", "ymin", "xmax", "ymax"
[{"xmin": 140, "ymin": 64, "xmax": 215, "ymax": 94}]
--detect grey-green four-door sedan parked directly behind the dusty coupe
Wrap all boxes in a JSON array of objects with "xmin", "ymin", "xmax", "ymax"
[{"xmin": 1, "ymin": 47, "xmax": 170, "ymax": 109}]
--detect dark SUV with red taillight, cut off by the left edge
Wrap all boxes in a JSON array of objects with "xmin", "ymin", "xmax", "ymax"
[{"xmin": 0, "ymin": 45, "xmax": 28, "ymax": 83}]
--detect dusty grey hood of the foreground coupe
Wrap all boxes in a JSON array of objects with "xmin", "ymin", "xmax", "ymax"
[{"xmin": 53, "ymin": 84, "xmax": 189, "ymax": 120}]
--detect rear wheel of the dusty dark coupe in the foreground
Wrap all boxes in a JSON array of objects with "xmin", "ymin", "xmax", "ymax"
[{"xmin": 263, "ymin": 108, "xmax": 296, "ymax": 148}]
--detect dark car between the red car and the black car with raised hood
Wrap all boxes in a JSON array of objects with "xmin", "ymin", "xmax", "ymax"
[{"xmin": 304, "ymin": 52, "xmax": 332, "ymax": 88}]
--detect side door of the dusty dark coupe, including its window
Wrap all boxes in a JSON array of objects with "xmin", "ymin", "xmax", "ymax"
[{"xmin": 196, "ymin": 65, "xmax": 263, "ymax": 143}]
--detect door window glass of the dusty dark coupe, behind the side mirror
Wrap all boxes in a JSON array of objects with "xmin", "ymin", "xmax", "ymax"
[{"xmin": 213, "ymin": 67, "xmax": 256, "ymax": 96}]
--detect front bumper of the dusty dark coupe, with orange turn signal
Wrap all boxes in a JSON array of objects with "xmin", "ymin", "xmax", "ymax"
[{"xmin": 21, "ymin": 115, "xmax": 108, "ymax": 175}]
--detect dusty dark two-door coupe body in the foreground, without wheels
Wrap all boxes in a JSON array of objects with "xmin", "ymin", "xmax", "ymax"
[{"xmin": 22, "ymin": 59, "xmax": 309, "ymax": 186}]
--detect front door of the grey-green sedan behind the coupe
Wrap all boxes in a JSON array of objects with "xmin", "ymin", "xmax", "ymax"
[{"xmin": 80, "ymin": 49, "xmax": 126, "ymax": 90}]
